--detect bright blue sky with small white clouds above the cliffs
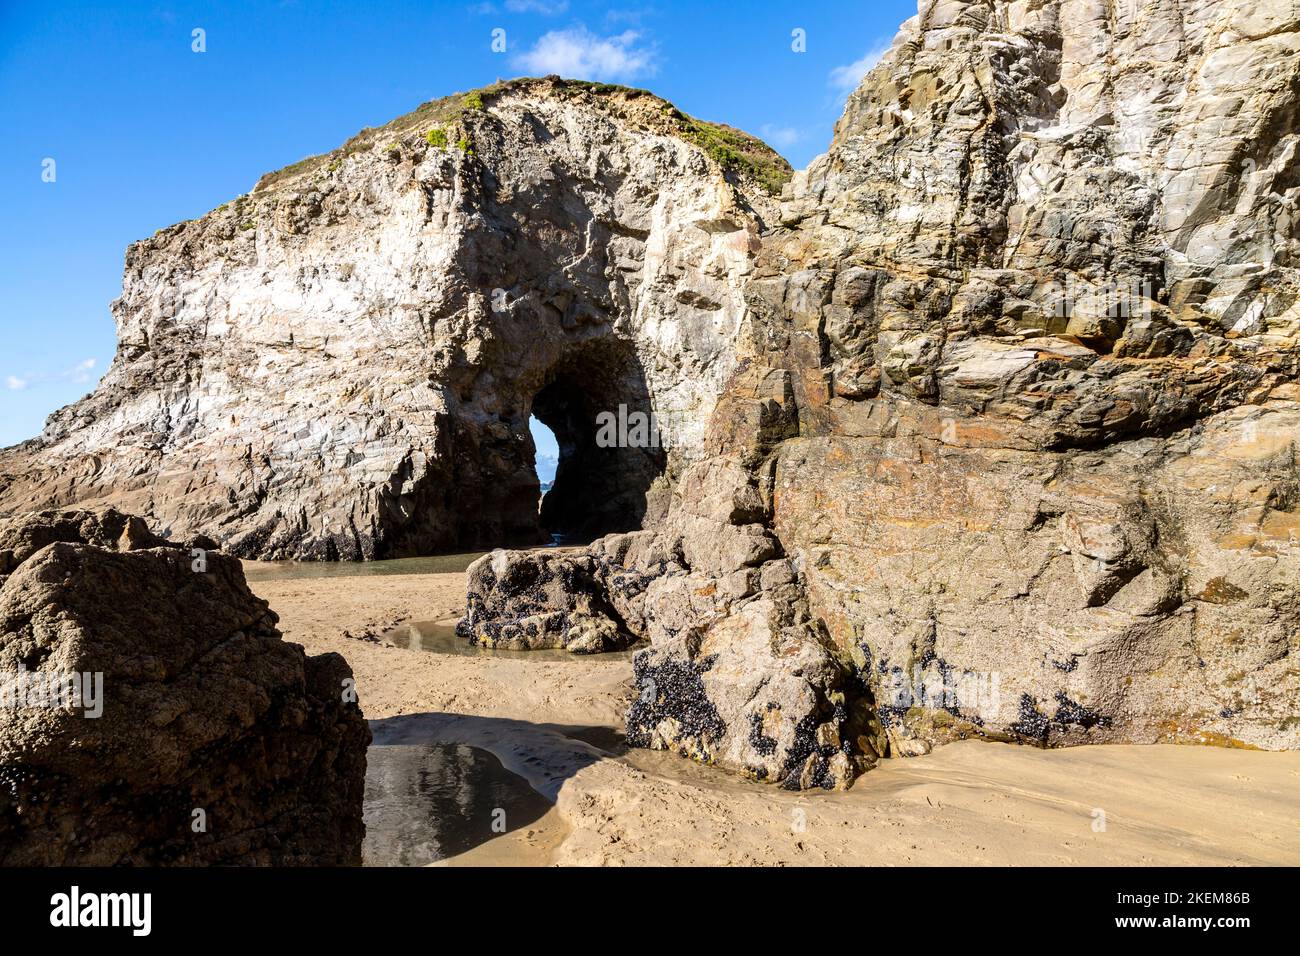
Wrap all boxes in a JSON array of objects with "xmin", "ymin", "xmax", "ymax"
[{"xmin": 0, "ymin": 0, "xmax": 917, "ymax": 446}]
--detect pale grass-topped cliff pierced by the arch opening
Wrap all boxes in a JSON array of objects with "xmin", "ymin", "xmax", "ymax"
[{"xmin": 0, "ymin": 81, "xmax": 788, "ymax": 559}]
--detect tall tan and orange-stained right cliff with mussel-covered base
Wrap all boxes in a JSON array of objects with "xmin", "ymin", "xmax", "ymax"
[{"xmin": 460, "ymin": 0, "xmax": 1300, "ymax": 787}]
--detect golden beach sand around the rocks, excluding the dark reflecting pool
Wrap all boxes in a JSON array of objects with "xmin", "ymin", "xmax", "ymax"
[{"xmin": 250, "ymin": 561, "xmax": 1300, "ymax": 866}]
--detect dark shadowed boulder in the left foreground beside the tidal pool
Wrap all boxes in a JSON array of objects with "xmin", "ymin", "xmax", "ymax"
[{"xmin": 0, "ymin": 511, "xmax": 371, "ymax": 866}]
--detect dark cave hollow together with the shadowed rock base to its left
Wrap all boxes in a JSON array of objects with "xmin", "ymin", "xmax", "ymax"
[{"xmin": 374, "ymin": 334, "xmax": 667, "ymax": 558}]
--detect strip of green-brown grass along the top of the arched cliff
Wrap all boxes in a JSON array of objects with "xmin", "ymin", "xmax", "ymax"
[{"xmin": 254, "ymin": 77, "xmax": 794, "ymax": 195}]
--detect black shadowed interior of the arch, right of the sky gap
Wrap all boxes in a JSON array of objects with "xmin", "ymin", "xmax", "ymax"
[{"xmin": 530, "ymin": 338, "xmax": 666, "ymax": 544}]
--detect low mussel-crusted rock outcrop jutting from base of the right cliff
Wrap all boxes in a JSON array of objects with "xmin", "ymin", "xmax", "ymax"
[{"xmin": 460, "ymin": 523, "xmax": 887, "ymax": 790}]
